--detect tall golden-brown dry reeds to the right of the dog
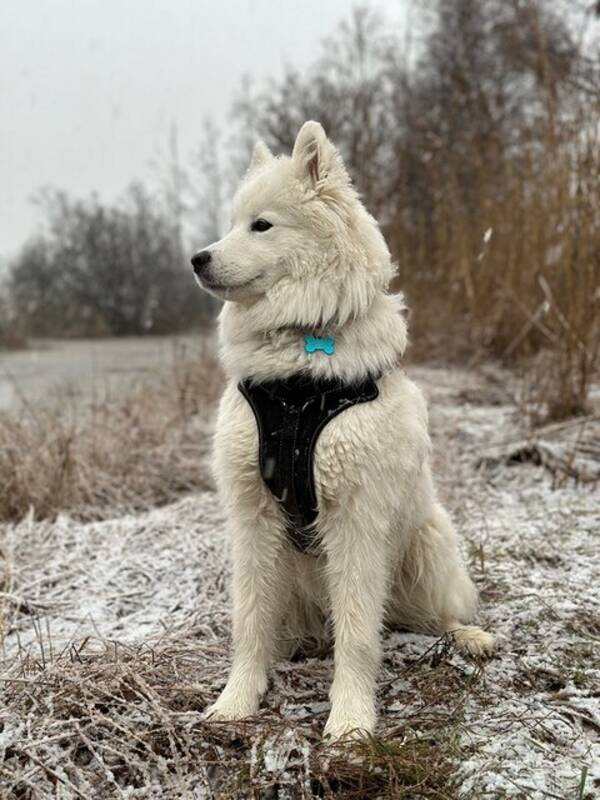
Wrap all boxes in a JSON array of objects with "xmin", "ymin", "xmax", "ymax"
[{"xmin": 388, "ymin": 126, "xmax": 600, "ymax": 423}]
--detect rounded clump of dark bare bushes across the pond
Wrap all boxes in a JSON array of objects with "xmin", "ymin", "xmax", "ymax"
[{"xmin": 10, "ymin": 184, "xmax": 206, "ymax": 336}]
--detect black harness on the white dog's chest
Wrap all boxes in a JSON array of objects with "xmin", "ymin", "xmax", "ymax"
[{"xmin": 238, "ymin": 374, "xmax": 379, "ymax": 553}]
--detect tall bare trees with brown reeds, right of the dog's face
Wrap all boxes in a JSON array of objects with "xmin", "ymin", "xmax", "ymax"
[{"xmin": 235, "ymin": 0, "xmax": 600, "ymax": 416}]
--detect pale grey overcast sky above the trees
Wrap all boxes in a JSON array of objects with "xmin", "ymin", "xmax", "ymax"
[{"xmin": 0, "ymin": 0, "xmax": 409, "ymax": 257}]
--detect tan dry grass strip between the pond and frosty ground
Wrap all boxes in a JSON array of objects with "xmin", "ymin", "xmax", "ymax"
[{"xmin": 0, "ymin": 344, "xmax": 221, "ymax": 521}]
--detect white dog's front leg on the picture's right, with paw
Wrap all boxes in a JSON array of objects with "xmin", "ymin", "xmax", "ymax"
[{"xmin": 323, "ymin": 510, "xmax": 390, "ymax": 739}]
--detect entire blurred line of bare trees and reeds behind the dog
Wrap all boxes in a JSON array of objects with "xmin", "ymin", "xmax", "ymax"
[{"xmin": 2, "ymin": 0, "xmax": 600, "ymax": 412}]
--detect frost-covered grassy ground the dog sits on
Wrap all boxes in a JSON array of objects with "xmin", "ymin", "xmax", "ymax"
[{"xmin": 0, "ymin": 368, "xmax": 600, "ymax": 800}]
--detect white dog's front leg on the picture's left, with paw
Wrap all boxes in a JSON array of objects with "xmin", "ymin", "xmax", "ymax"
[{"xmin": 206, "ymin": 520, "xmax": 290, "ymax": 720}]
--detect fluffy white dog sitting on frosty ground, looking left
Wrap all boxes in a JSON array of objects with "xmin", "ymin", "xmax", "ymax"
[{"xmin": 192, "ymin": 122, "xmax": 494, "ymax": 739}]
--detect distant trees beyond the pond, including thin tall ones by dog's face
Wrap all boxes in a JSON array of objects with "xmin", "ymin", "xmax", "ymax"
[{"xmin": 0, "ymin": 123, "xmax": 219, "ymax": 346}]
